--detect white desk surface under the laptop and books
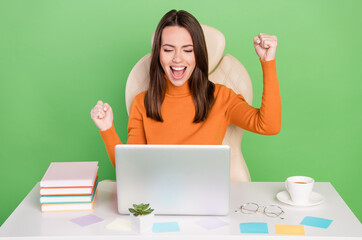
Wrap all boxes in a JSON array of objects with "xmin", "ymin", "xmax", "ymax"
[{"xmin": 0, "ymin": 182, "xmax": 362, "ymax": 240}]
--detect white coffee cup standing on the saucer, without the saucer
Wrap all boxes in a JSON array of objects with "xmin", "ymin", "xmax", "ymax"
[{"xmin": 285, "ymin": 176, "xmax": 314, "ymax": 204}]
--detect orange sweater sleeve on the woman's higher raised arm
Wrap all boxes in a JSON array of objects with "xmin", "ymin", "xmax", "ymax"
[{"xmin": 227, "ymin": 59, "xmax": 282, "ymax": 135}]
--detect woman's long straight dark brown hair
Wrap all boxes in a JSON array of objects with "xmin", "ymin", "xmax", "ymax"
[{"xmin": 144, "ymin": 10, "xmax": 215, "ymax": 123}]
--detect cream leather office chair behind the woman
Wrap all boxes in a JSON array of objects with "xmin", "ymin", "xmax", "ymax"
[{"xmin": 126, "ymin": 25, "xmax": 253, "ymax": 182}]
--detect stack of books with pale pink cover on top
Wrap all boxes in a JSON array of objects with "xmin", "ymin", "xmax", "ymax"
[{"xmin": 40, "ymin": 162, "xmax": 98, "ymax": 212}]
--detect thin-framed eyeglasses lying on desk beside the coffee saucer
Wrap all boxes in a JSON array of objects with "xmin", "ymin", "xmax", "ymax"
[{"xmin": 235, "ymin": 203, "xmax": 284, "ymax": 219}]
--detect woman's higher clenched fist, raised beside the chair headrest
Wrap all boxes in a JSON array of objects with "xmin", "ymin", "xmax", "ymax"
[{"xmin": 254, "ymin": 33, "xmax": 278, "ymax": 61}]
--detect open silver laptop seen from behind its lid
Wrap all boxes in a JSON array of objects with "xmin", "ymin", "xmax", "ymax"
[{"xmin": 115, "ymin": 144, "xmax": 230, "ymax": 215}]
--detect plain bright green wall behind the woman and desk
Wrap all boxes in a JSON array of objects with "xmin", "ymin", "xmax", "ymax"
[{"xmin": 0, "ymin": 0, "xmax": 362, "ymax": 224}]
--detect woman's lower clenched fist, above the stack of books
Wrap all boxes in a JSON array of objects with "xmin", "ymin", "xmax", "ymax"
[{"xmin": 91, "ymin": 101, "xmax": 113, "ymax": 131}]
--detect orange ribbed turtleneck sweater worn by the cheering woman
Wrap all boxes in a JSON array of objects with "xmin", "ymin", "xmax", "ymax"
[{"xmin": 100, "ymin": 60, "xmax": 281, "ymax": 166}]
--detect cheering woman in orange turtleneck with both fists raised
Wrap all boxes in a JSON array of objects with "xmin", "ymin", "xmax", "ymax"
[{"xmin": 91, "ymin": 10, "xmax": 281, "ymax": 174}]
